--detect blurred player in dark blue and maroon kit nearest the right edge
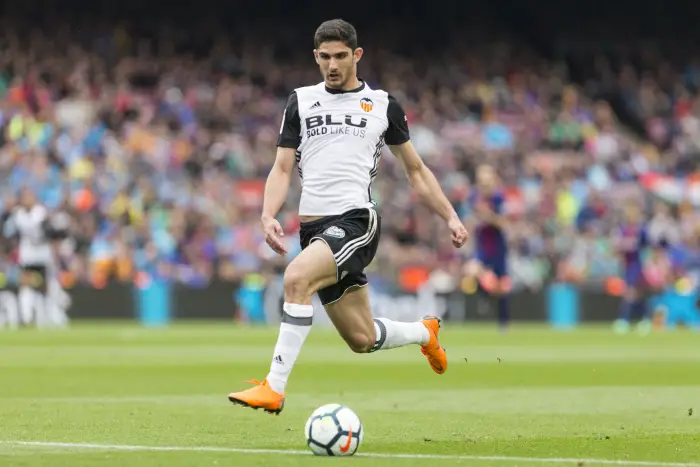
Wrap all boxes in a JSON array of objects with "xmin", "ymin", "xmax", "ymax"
[{"xmin": 614, "ymin": 201, "xmax": 651, "ymax": 333}]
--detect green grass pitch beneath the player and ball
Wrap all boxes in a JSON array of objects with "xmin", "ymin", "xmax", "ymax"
[{"xmin": 0, "ymin": 322, "xmax": 700, "ymax": 467}]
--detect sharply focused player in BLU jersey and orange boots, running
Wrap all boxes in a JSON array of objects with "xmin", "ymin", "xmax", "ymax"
[{"xmin": 229, "ymin": 20, "xmax": 468, "ymax": 414}]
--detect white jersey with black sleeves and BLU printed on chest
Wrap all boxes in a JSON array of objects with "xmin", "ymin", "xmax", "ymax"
[{"xmin": 277, "ymin": 81, "xmax": 409, "ymax": 216}]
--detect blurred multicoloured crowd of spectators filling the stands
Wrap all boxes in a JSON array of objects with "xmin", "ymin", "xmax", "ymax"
[{"xmin": 0, "ymin": 16, "xmax": 700, "ymax": 296}]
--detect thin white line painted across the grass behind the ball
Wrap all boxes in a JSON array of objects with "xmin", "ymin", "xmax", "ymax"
[{"xmin": 0, "ymin": 441, "xmax": 700, "ymax": 467}]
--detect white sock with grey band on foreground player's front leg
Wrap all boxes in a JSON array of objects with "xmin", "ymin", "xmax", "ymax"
[{"xmin": 267, "ymin": 302, "xmax": 314, "ymax": 394}]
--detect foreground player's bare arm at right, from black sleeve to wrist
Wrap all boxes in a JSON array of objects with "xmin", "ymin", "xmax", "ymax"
[{"xmin": 389, "ymin": 141, "xmax": 459, "ymax": 222}]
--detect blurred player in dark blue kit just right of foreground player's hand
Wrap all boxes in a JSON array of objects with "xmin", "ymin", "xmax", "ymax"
[{"xmin": 468, "ymin": 165, "xmax": 511, "ymax": 330}]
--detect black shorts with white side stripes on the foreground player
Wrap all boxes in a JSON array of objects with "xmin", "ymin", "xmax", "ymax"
[{"xmin": 299, "ymin": 208, "xmax": 381, "ymax": 305}]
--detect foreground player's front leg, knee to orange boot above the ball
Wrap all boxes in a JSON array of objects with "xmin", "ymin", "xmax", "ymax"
[{"xmin": 229, "ymin": 241, "xmax": 337, "ymax": 413}]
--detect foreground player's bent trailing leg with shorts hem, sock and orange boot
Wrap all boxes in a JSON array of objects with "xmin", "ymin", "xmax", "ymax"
[{"xmin": 319, "ymin": 284, "xmax": 447, "ymax": 374}]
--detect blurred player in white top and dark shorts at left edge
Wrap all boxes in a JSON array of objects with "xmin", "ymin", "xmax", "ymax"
[{"xmin": 8, "ymin": 188, "xmax": 67, "ymax": 327}]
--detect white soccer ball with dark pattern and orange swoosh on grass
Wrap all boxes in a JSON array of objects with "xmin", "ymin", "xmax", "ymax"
[{"xmin": 304, "ymin": 404, "xmax": 362, "ymax": 456}]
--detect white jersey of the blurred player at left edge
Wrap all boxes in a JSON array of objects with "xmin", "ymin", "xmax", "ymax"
[{"xmin": 12, "ymin": 204, "xmax": 53, "ymax": 266}]
